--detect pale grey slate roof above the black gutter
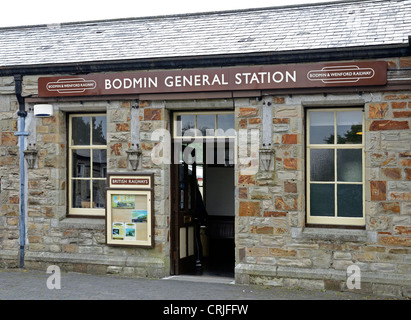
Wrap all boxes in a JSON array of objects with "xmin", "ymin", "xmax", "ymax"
[{"xmin": 0, "ymin": 0, "xmax": 411, "ymax": 68}]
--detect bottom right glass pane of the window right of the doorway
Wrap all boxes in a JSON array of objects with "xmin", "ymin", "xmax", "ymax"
[{"xmin": 337, "ymin": 184, "xmax": 362, "ymax": 218}]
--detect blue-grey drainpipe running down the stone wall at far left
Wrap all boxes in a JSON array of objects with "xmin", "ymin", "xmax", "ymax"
[{"xmin": 14, "ymin": 75, "xmax": 29, "ymax": 268}]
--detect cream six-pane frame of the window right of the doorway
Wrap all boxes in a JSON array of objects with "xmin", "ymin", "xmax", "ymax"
[{"xmin": 306, "ymin": 107, "xmax": 365, "ymax": 226}]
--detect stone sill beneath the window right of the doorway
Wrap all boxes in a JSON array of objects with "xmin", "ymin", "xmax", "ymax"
[{"xmin": 291, "ymin": 227, "xmax": 376, "ymax": 242}]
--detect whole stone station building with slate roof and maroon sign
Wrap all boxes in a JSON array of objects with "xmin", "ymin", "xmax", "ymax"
[{"xmin": 0, "ymin": 0, "xmax": 411, "ymax": 297}]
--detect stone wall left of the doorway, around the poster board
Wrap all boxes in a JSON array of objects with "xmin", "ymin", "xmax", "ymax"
[{"xmin": 0, "ymin": 81, "xmax": 170, "ymax": 277}]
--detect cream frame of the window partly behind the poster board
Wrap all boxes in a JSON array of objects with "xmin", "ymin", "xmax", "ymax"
[{"xmin": 68, "ymin": 113, "xmax": 107, "ymax": 217}]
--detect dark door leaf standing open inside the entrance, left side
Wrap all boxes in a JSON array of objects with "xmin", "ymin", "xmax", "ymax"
[{"xmin": 171, "ymin": 143, "xmax": 202, "ymax": 274}]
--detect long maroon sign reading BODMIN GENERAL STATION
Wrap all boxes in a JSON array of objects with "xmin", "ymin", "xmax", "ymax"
[{"xmin": 38, "ymin": 61, "xmax": 387, "ymax": 97}]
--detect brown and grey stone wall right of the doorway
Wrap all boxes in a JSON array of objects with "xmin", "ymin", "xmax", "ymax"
[{"xmin": 236, "ymin": 91, "xmax": 411, "ymax": 296}]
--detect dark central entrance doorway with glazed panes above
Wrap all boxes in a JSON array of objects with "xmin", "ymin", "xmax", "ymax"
[{"xmin": 171, "ymin": 113, "xmax": 235, "ymax": 277}]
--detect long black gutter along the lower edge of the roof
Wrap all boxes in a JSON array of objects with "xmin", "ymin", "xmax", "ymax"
[{"xmin": 0, "ymin": 43, "xmax": 411, "ymax": 76}]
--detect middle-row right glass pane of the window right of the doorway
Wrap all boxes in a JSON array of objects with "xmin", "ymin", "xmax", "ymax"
[{"xmin": 337, "ymin": 149, "xmax": 362, "ymax": 182}]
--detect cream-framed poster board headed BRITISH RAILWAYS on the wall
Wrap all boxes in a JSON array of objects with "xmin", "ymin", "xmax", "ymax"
[{"xmin": 106, "ymin": 174, "xmax": 154, "ymax": 247}]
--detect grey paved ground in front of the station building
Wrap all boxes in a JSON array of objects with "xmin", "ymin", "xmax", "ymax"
[{"xmin": 0, "ymin": 269, "xmax": 400, "ymax": 301}]
